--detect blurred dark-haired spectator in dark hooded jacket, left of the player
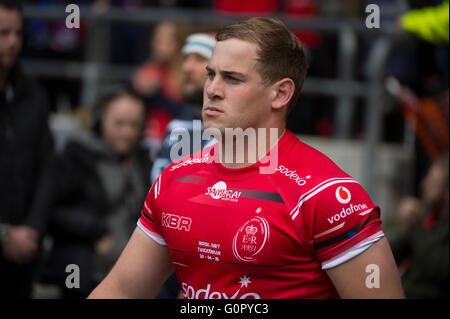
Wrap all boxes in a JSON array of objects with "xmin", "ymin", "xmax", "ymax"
[{"xmin": 42, "ymin": 87, "xmax": 151, "ymax": 298}]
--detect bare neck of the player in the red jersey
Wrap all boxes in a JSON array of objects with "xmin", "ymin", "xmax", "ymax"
[{"xmin": 220, "ymin": 127, "xmax": 286, "ymax": 169}]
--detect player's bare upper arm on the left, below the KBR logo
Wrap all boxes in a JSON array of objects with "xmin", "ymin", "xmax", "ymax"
[{"xmin": 89, "ymin": 227, "xmax": 173, "ymax": 299}]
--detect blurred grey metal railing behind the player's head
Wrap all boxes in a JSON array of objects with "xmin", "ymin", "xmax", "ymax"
[{"xmin": 23, "ymin": 6, "xmax": 414, "ymax": 199}]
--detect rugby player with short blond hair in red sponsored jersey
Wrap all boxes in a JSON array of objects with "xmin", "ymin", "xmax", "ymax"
[{"xmin": 91, "ymin": 18, "xmax": 403, "ymax": 299}]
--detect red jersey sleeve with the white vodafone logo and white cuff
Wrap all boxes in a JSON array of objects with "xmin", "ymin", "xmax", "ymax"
[{"xmin": 292, "ymin": 178, "xmax": 384, "ymax": 269}]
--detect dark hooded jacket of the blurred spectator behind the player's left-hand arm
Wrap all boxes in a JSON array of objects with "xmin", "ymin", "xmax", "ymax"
[{"xmin": 42, "ymin": 134, "xmax": 151, "ymax": 296}]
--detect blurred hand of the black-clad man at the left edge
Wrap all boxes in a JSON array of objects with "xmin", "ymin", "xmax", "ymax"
[{"xmin": 3, "ymin": 225, "xmax": 39, "ymax": 265}]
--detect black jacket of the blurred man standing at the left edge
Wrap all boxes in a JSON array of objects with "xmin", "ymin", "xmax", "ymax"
[{"xmin": 0, "ymin": 68, "xmax": 53, "ymax": 235}]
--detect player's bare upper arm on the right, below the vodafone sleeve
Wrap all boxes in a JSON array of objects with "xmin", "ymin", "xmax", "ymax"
[{"xmin": 326, "ymin": 238, "xmax": 404, "ymax": 298}]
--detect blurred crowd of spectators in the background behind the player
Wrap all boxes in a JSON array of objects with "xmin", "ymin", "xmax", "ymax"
[{"xmin": 0, "ymin": 0, "xmax": 449, "ymax": 298}]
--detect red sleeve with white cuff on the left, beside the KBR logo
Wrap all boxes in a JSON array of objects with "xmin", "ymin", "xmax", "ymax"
[{"xmin": 137, "ymin": 175, "xmax": 167, "ymax": 246}]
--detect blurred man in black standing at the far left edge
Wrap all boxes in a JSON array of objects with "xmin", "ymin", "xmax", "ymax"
[{"xmin": 0, "ymin": 0, "xmax": 53, "ymax": 299}]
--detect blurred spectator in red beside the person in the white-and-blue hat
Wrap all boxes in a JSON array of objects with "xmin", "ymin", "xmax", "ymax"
[{"xmin": 133, "ymin": 21, "xmax": 190, "ymax": 157}]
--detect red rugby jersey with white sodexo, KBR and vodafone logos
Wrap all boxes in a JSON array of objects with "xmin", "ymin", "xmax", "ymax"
[{"xmin": 138, "ymin": 131, "xmax": 383, "ymax": 299}]
